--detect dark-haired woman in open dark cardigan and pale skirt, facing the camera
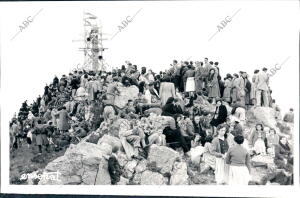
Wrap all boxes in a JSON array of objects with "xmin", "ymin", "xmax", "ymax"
[{"xmin": 211, "ymin": 123, "xmax": 229, "ymax": 184}]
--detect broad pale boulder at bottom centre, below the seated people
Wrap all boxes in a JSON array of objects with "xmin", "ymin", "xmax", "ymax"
[{"xmin": 148, "ymin": 144, "xmax": 179, "ymax": 174}]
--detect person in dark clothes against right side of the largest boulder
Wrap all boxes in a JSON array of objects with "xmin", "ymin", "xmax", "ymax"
[{"xmin": 108, "ymin": 146, "xmax": 122, "ymax": 185}]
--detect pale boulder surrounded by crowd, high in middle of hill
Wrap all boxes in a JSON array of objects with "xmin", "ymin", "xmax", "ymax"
[{"xmin": 114, "ymin": 85, "xmax": 139, "ymax": 109}]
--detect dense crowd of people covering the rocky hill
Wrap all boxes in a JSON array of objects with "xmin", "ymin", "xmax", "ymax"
[{"xmin": 10, "ymin": 58, "xmax": 293, "ymax": 184}]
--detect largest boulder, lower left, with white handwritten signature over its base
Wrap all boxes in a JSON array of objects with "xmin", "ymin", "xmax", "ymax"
[{"xmin": 39, "ymin": 142, "xmax": 105, "ymax": 185}]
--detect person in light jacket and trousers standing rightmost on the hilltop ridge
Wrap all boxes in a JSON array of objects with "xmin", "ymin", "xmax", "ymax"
[{"xmin": 256, "ymin": 67, "xmax": 269, "ymax": 107}]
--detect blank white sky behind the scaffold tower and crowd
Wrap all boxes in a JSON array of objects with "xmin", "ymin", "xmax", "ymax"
[{"xmin": 0, "ymin": 1, "xmax": 299, "ymax": 118}]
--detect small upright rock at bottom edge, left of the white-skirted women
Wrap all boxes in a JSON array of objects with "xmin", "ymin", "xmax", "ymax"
[{"xmin": 170, "ymin": 162, "xmax": 189, "ymax": 185}]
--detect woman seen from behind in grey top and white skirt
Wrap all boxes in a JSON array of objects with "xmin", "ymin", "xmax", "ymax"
[{"xmin": 225, "ymin": 135, "xmax": 251, "ymax": 185}]
